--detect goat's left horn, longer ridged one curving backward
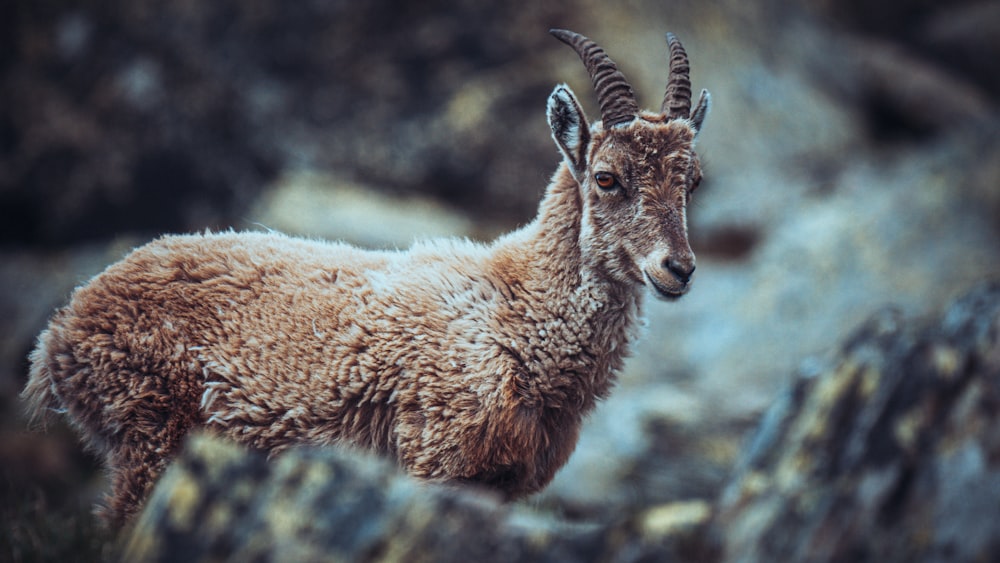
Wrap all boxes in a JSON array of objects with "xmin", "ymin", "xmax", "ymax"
[{"xmin": 549, "ymin": 29, "xmax": 639, "ymax": 129}]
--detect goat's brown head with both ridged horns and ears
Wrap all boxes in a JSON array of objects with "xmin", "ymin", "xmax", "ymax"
[{"xmin": 548, "ymin": 30, "xmax": 710, "ymax": 299}]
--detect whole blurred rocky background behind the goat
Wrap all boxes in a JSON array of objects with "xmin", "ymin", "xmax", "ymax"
[{"xmin": 0, "ymin": 0, "xmax": 1000, "ymax": 561}]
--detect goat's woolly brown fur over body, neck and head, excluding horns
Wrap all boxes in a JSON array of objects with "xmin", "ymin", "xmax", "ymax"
[{"xmin": 23, "ymin": 74, "xmax": 700, "ymax": 525}]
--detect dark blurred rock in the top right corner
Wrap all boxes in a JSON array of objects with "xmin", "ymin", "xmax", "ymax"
[{"xmin": 784, "ymin": 0, "xmax": 1000, "ymax": 143}]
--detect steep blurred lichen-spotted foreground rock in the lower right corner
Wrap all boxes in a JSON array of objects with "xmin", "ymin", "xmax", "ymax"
[{"xmin": 713, "ymin": 283, "xmax": 1000, "ymax": 562}]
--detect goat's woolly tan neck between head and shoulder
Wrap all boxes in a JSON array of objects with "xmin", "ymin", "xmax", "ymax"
[{"xmin": 495, "ymin": 165, "xmax": 641, "ymax": 408}]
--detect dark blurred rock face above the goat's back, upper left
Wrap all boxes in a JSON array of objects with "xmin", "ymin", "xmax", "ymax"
[{"xmin": 0, "ymin": 0, "xmax": 578, "ymax": 247}]
